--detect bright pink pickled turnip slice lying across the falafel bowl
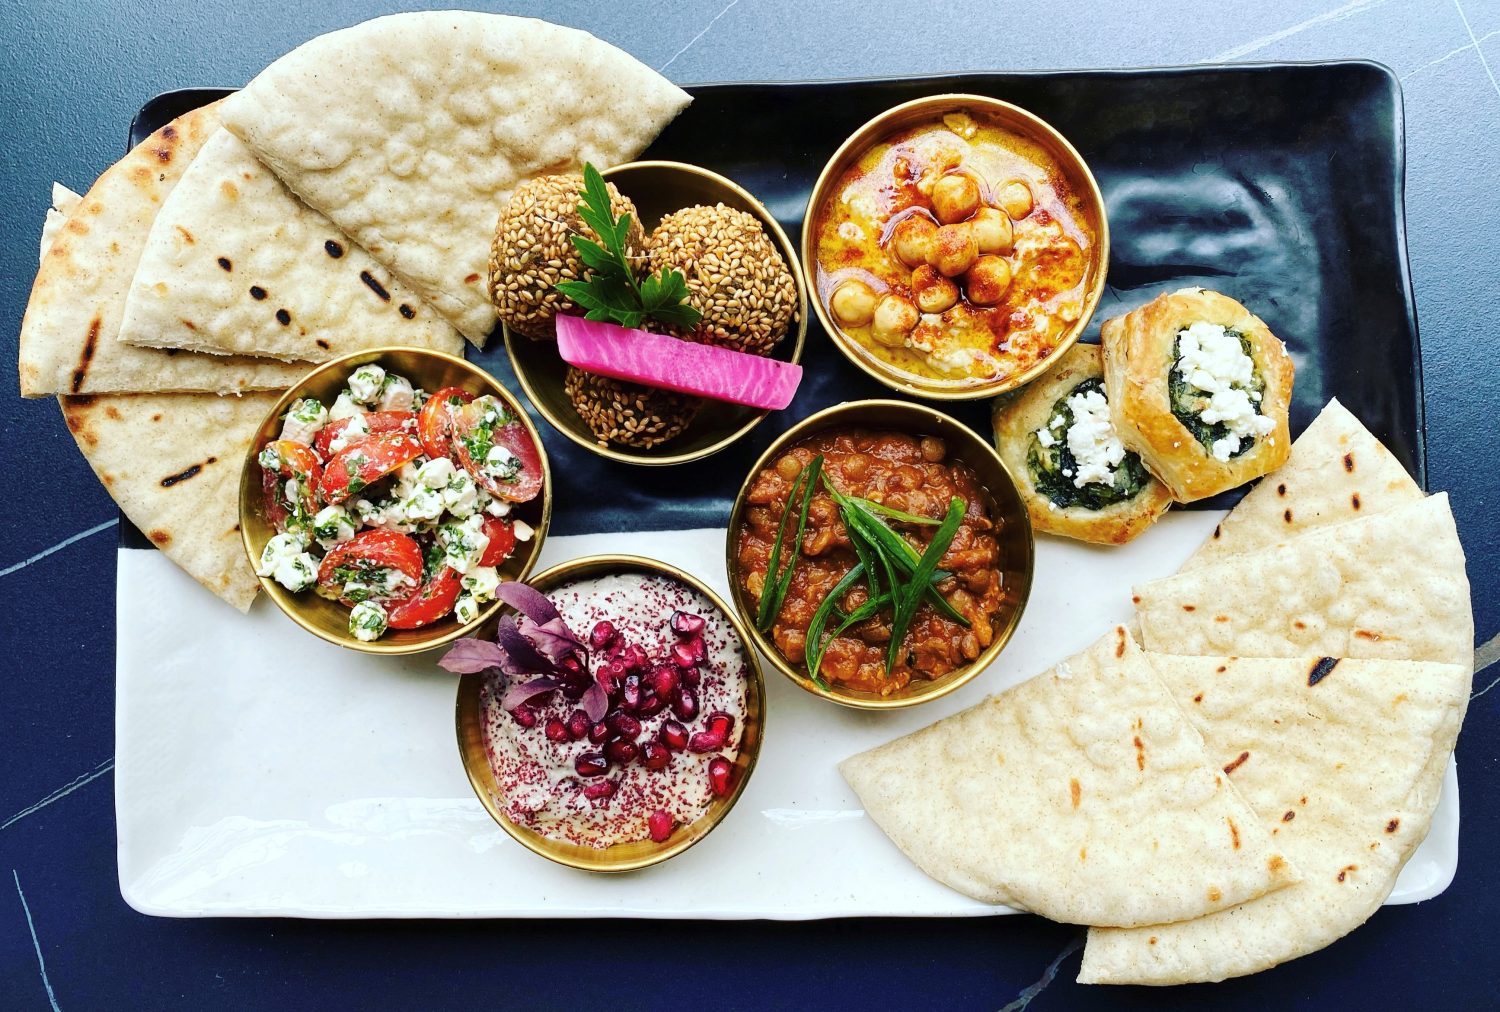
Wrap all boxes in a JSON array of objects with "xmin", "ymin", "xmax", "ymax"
[{"xmin": 557, "ymin": 316, "xmax": 803, "ymax": 411}]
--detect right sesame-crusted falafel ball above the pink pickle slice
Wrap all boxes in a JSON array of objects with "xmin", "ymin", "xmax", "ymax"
[{"xmin": 647, "ymin": 204, "xmax": 797, "ymax": 355}]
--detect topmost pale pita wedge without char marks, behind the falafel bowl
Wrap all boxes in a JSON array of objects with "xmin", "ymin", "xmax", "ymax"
[{"xmin": 224, "ymin": 10, "xmax": 689, "ymax": 345}]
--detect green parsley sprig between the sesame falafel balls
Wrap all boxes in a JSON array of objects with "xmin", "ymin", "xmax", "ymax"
[{"xmin": 557, "ymin": 165, "xmax": 702, "ymax": 328}]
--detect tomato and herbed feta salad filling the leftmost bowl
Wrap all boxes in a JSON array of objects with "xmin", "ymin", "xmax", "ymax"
[{"xmin": 257, "ymin": 364, "xmax": 542, "ymax": 640}]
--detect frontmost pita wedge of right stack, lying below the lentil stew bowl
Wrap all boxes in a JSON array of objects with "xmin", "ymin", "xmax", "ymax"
[{"xmin": 839, "ymin": 627, "xmax": 1299, "ymax": 925}]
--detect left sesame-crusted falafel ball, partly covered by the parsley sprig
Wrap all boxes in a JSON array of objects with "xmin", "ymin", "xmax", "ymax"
[{"xmin": 489, "ymin": 172, "xmax": 645, "ymax": 340}]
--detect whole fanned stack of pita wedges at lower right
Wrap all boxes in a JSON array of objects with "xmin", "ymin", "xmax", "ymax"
[{"xmin": 840, "ymin": 402, "xmax": 1473, "ymax": 984}]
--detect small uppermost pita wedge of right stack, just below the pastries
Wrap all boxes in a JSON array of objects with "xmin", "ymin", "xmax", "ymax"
[{"xmin": 1182, "ymin": 400, "xmax": 1425, "ymax": 570}]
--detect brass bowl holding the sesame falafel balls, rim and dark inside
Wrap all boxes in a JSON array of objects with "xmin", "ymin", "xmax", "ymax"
[{"xmin": 504, "ymin": 162, "xmax": 807, "ymax": 466}]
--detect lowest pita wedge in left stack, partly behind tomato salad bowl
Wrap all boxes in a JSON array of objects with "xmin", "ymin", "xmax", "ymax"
[{"xmin": 59, "ymin": 393, "xmax": 276, "ymax": 612}]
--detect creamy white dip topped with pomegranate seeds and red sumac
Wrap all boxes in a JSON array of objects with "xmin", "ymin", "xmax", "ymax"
[{"xmin": 482, "ymin": 573, "xmax": 750, "ymax": 849}]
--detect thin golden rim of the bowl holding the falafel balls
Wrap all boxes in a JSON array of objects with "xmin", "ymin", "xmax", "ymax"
[{"xmin": 501, "ymin": 159, "xmax": 812, "ymax": 468}]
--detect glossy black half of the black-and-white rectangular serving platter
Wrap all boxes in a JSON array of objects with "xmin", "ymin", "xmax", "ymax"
[{"xmin": 122, "ymin": 61, "xmax": 1427, "ymax": 547}]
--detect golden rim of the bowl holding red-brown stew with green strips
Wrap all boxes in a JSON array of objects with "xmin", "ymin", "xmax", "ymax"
[{"xmin": 725, "ymin": 397, "xmax": 1037, "ymax": 711}]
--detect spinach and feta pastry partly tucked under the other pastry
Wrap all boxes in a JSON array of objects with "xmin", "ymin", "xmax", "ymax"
[{"xmin": 995, "ymin": 345, "xmax": 1172, "ymax": 544}]
